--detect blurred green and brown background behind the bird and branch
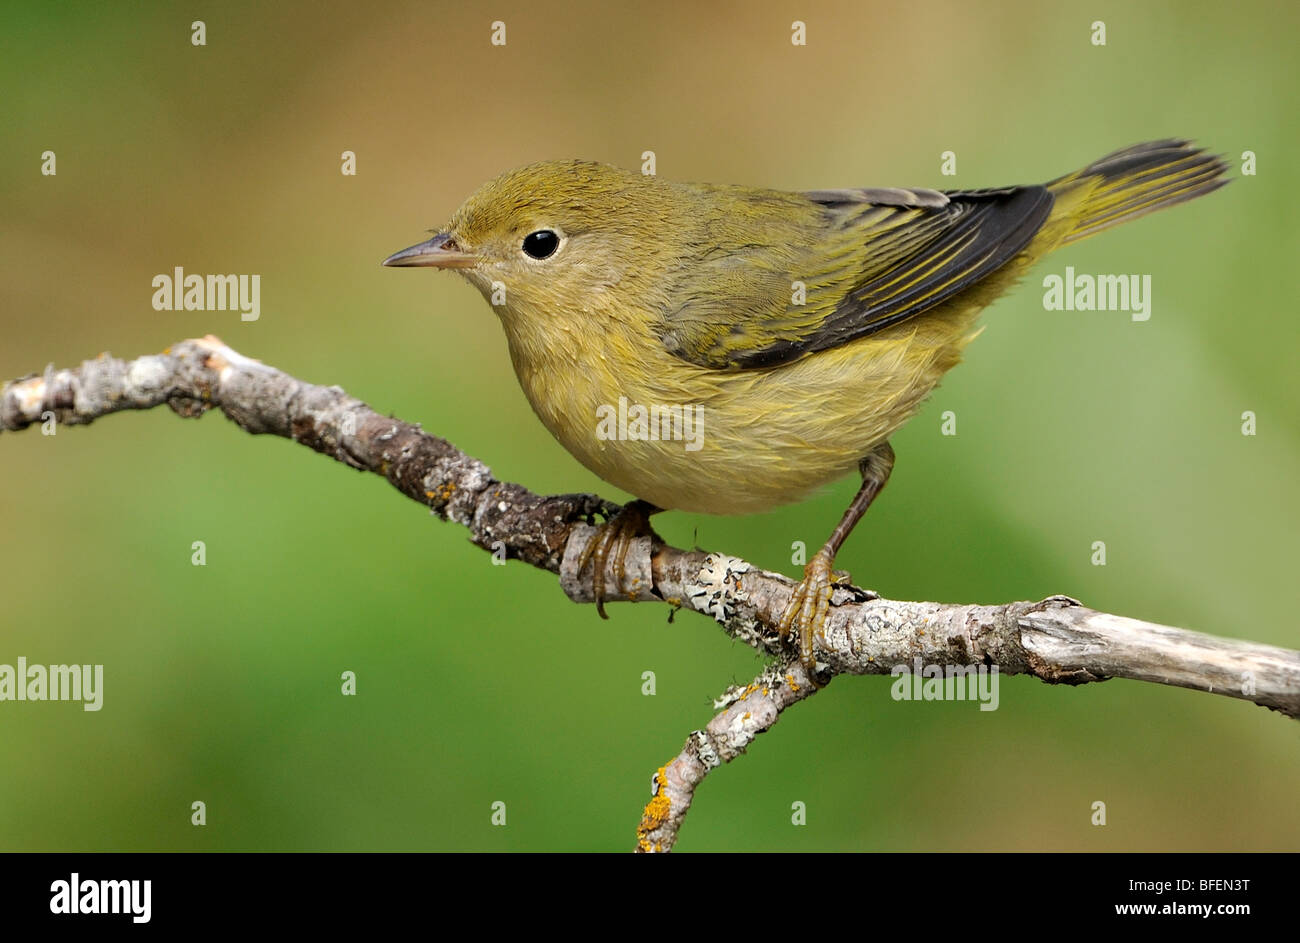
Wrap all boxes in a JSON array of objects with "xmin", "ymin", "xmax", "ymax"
[{"xmin": 0, "ymin": 0, "xmax": 1300, "ymax": 851}]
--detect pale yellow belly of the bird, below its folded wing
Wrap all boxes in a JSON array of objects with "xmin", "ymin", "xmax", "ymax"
[{"xmin": 506, "ymin": 310, "xmax": 966, "ymax": 514}]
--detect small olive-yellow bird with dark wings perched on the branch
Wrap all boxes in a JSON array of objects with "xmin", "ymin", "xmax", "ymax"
[{"xmin": 384, "ymin": 139, "xmax": 1229, "ymax": 684}]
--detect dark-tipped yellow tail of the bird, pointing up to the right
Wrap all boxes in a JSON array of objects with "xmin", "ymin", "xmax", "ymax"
[{"xmin": 1047, "ymin": 139, "xmax": 1229, "ymax": 245}]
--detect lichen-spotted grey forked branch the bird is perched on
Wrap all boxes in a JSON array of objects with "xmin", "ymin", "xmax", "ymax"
[{"xmin": 0, "ymin": 334, "xmax": 1300, "ymax": 851}]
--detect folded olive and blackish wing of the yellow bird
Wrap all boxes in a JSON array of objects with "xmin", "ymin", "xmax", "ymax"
[{"xmin": 659, "ymin": 186, "xmax": 1053, "ymax": 369}]
